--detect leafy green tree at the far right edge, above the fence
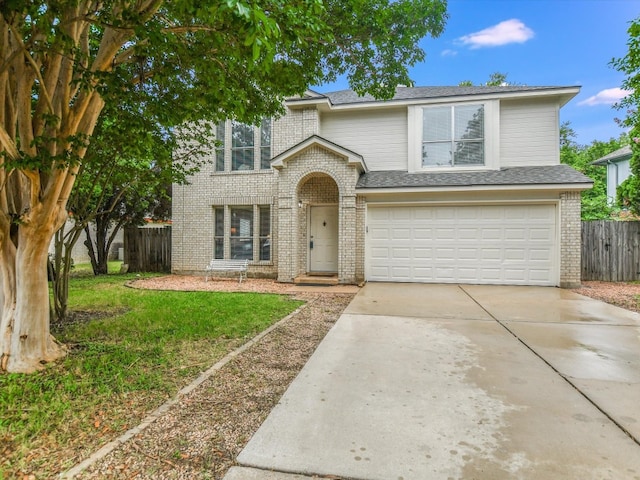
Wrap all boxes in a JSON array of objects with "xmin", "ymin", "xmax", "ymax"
[{"xmin": 610, "ymin": 17, "xmax": 640, "ymax": 215}]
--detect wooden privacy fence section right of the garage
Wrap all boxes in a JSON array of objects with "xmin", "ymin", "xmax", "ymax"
[{"xmin": 582, "ymin": 220, "xmax": 640, "ymax": 282}]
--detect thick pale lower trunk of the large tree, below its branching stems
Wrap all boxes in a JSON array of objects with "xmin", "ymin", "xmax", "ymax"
[{"xmin": 0, "ymin": 217, "xmax": 65, "ymax": 373}]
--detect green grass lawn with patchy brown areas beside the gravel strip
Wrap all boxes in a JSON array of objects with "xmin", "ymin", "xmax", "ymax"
[{"xmin": 0, "ymin": 266, "xmax": 301, "ymax": 479}]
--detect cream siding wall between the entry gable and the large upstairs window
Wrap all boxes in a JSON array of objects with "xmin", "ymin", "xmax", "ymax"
[{"xmin": 320, "ymin": 108, "xmax": 408, "ymax": 170}]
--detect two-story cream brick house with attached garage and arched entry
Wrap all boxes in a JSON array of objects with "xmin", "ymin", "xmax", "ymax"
[{"xmin": 172, "ymin": 86, "xmax": 592, "ymax": 287}]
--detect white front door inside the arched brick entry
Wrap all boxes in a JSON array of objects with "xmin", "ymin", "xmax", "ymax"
[{"xmin": 308, "ymin": 205, "xmax": 338, "ymax": 272}]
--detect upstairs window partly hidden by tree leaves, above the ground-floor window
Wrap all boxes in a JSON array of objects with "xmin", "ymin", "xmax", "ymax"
[{"xmin": 215, "ymin": 118, "xmax": 271, "ymax": 172}]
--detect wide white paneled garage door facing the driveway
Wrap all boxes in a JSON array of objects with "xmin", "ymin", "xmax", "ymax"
[{"xmin": 366, "ymin": 205, "xmax": 558, "ymax": 285}]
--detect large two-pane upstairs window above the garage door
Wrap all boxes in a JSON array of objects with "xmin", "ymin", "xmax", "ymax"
[{"xmin": 422, "ymin": 105, "xmax": 485, "ymax": 168}]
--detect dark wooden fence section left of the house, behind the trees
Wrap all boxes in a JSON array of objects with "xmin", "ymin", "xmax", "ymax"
[{"xmin": 124, "ymin": 227, "xmax": 171, "ymax": 273}]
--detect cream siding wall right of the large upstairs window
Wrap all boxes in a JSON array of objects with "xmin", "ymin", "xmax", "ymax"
[{"xmin": 500, "ymin": 100, "xmax": 560, "ymax": 167}]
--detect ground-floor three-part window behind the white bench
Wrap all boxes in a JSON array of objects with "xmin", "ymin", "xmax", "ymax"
[{"xmin": 213, "ymin": 205, "xmax": 271, "ymax": 261}]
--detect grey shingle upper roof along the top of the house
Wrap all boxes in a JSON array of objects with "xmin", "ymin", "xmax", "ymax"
[{"xmin": 324, "ymin": 85, "xmax": 574, "ymax": 105}]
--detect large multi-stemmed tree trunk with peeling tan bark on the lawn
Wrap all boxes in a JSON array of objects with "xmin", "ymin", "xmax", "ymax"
[{"xmin": 0, "ymin": 0, "xmax": 162, "ymax": 372}]
